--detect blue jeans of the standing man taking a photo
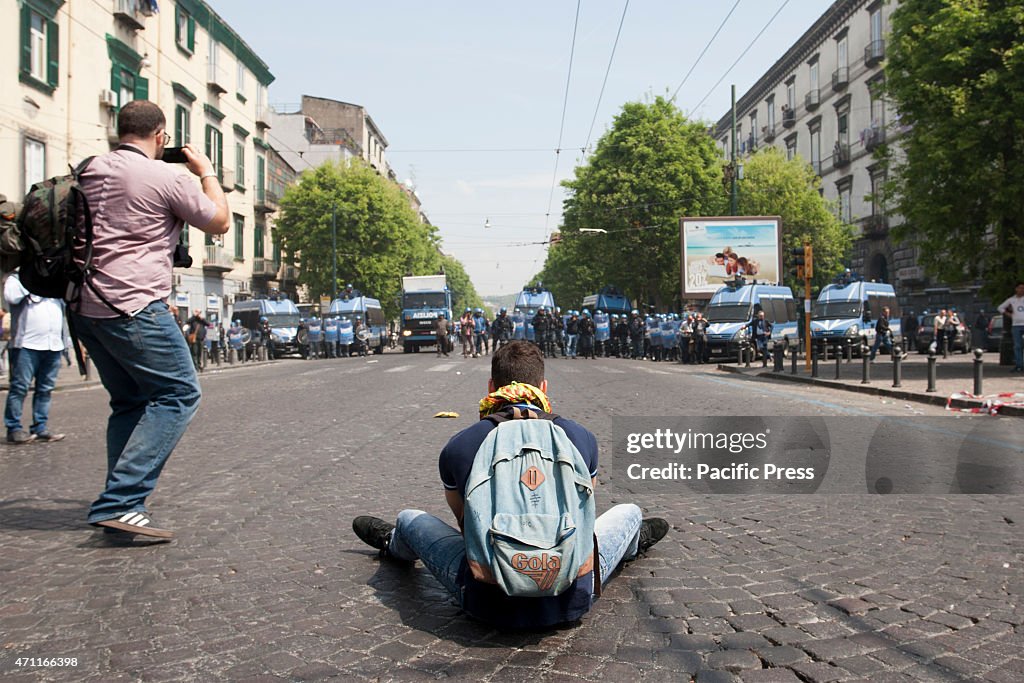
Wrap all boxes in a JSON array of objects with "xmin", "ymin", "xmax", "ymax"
[{"xmin": 72, "ymin": 301, "xmax": 201, "ymax": 522}]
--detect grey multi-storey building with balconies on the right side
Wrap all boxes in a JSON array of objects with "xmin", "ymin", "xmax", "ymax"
[{"xmin": 714, "ymin": 0, "xmax": 978, "ymax": 312}]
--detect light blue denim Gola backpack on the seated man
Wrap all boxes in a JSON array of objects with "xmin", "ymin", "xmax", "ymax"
[{"xmin": 463, "ymin": 409, "xmax": 596, "ymax": 597}]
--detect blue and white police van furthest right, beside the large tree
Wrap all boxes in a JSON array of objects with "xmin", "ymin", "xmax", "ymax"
[{"xmin": 811, "ymin": 282, "xmax": 903, "ymax": 350}]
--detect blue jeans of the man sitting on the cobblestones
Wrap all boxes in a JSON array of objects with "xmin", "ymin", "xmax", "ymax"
[{"xmin": 388, "ymin": 503, "xmax": 643, "ymax": 604}]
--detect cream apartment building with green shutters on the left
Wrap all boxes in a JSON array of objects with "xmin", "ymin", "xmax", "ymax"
[{"xmin": 0, "ymin": 0, "xmax": 295, "ymax": 317}]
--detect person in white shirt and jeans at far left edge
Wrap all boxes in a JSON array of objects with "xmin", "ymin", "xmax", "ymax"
[{"xmin": 3, "ymin": 269, "xmax": 70, "ymax": 445}]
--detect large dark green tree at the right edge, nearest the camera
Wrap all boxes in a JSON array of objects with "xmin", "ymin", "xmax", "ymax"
[{"xmin": 881, "ymin": 0, "xmax": 1024, "ymax": 297}]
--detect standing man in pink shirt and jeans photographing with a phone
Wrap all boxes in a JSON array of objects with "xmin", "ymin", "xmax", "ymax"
[{"xmin": 72, "ymin": 100, "xmax": 229, "ymax": 539}]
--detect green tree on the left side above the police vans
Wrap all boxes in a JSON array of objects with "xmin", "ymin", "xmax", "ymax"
[{"xmin": 274, "ymin": 162, "xmax": 476, "ymax": 316}]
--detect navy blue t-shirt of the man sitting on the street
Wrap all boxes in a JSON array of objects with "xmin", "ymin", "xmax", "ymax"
[{"xmin": 438, "ymin": 417, "xmax": 597, "ymax": 629}]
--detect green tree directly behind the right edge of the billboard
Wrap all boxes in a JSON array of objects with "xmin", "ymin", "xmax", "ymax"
[{"xmin": 738, "ymin": 147, "xmax": 853, "ymax": 292}]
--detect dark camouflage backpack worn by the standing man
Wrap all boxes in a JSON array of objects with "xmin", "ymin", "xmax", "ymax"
[{"xmin": 0, "ymin": 157, "xmax": 92, "ymax": 301}]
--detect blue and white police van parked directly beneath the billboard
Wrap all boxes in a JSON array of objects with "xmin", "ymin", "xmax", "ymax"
[{"xmin": 706, "ymin": 285, "xmax": 798, "ymax": 357}]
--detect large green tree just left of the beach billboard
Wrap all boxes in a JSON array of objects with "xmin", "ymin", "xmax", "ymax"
[{"xmin": 538, "ymin": 97, "xmax": 723, "ymax": 308}]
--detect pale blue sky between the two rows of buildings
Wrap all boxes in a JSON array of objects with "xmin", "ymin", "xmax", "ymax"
[{"xmin": 208, "ymin": 0, "xmax": 833, "ymax": 296}]
